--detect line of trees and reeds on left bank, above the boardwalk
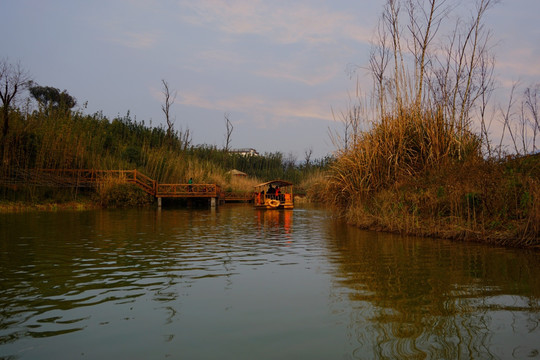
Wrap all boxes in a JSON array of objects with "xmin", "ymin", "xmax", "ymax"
[{"xmin": 0, "ymin": 59, "xmax": 332, "ymax": 198}]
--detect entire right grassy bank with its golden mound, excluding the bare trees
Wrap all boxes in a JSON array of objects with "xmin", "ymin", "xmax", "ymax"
[{"xmin": 308, "ymin": 113, "xmax": 540, "ymax": 247}]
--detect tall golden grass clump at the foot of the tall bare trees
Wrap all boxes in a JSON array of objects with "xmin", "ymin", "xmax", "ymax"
[{"xmin": 326, "ymin": 109, "xmax": 481, "ymax": 198}]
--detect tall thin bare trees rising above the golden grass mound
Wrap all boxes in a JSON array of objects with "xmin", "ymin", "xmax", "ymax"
[{"xmin": 368, "ymin": 0, "xmax": 498, "ymax": 157}]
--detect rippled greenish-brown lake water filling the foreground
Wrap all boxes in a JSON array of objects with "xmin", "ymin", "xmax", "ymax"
[{"xmin": 0, "ymin": 205, "xmax": 540, "ymax": 360}]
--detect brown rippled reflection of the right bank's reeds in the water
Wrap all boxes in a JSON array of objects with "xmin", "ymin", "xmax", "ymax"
[{"xmin": 328, "ymin": 224, "xmax": 540, "ymax": 359}]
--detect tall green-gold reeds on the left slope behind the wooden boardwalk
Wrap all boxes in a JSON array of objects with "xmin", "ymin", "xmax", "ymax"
[{"xmin": 0, "ymin": 109, "xmax": 257, "ymax": 202}]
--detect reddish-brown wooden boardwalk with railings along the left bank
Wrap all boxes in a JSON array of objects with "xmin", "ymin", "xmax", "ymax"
[{"xmin": 0, "ymin": 169, "xmax": 253, "ymax": 204}]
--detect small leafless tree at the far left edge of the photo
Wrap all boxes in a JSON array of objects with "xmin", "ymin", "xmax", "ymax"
[{"xmin": 0, "ymin": 59, "xmax": 30, "ymax": 139}]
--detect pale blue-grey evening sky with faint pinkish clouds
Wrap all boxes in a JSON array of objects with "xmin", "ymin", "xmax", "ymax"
[{"xmin": 0, "ymin": 0, "xmax": 540, "ymax": 159}]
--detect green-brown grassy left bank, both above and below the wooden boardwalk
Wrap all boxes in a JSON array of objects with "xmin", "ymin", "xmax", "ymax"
[{"xmin": 0, "ymin": 107, "xmax": 326, "ymax": 211}]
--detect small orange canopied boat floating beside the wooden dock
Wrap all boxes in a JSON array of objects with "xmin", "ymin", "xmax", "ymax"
[{"xmin": 255, "ymin": 180, "xmax": 294, "ymax": 209}]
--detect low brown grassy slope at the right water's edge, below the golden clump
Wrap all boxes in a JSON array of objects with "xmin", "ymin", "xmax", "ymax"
[{"xmin": 345, "ymin": 158, "xmax": 540, "ymax": 247}]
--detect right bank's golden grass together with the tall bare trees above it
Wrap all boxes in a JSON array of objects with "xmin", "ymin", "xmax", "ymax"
[{"xmin": 316, "ymin": 0, "xmax": 540, "ymax": 247}]
